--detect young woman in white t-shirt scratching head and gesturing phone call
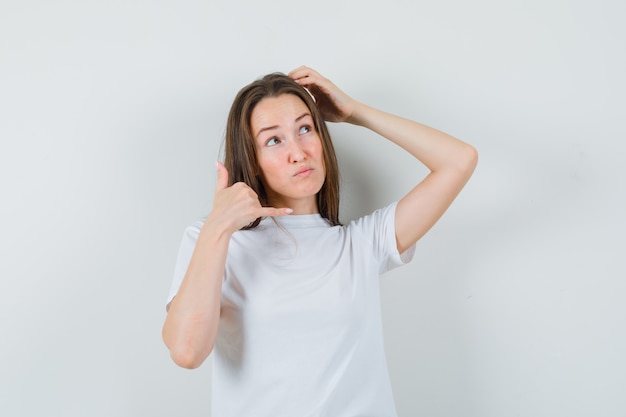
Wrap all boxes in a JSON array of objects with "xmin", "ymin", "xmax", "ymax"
[{"xmin": 163, "ymin": 67, "xmax": 477, "ymax": 417}]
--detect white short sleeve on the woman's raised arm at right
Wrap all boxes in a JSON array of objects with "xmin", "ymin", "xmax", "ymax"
[{"xmin": 350, "ymin": 202, "xmax": 415, "ymax": 274}]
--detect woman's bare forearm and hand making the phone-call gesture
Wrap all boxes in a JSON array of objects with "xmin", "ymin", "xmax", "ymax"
[{"xmin": 163, "ymin": 163, "xmax": 290, "ymax": 369}]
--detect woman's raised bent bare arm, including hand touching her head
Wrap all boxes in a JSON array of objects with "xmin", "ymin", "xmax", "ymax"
[{"xmin": 289, "ymin": 67, "xmax": 478, "ymax": 253}]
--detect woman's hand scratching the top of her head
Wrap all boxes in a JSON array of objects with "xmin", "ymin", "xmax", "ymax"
[{"xmin": 288, "ymin": 66, "xmax": 357, "ymax": 122}]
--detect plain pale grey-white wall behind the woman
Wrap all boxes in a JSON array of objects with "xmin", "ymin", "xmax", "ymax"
[{"xmin": 0, "ymin": 0, "xmax": 626, "ymax": 417}]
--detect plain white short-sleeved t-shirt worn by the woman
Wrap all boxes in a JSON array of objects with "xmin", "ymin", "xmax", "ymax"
[{"xmin": 168, "ymin": 203, "xmax": 415, "ymax": 417}]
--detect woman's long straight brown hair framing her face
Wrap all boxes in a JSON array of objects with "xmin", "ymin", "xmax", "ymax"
[{"xmin": 224, "ymin": 73, "xmax": 341, "ymax": 229}]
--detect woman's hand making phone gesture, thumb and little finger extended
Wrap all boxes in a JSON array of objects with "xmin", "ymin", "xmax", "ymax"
[{"xmin": 210, "ymin": 162, "xmax": 292, "ymax": 232}]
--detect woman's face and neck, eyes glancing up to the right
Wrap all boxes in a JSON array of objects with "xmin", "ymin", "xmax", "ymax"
[{"xmin": 250, "ymin": 94, "xmax": 326, "ymax": 214}]
